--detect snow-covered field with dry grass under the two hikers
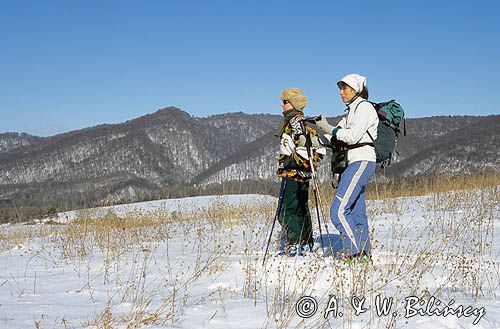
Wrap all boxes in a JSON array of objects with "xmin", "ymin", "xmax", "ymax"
[{"xmin": 0, "ymin": 187, "xmax": 500, "ymax": 329}]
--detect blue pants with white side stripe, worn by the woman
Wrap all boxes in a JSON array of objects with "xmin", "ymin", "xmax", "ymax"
[{"xmin": 330, "ymin": 161, "xmax": 375, "ymax": 255}]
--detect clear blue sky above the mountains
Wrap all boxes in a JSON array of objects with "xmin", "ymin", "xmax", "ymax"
[{"xmin": 0, "ymin": 0, "xmax": 500, "ymax": 136}]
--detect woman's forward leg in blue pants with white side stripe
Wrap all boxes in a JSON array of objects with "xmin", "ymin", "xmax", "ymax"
[{"xmin": 330, "ymin": 161, "xmax": 375, "ymax": 255}]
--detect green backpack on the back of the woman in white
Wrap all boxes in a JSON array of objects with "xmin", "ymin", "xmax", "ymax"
[{"xmin": 368, "ymin": 99, "xmax": 406, "ymax": 168}]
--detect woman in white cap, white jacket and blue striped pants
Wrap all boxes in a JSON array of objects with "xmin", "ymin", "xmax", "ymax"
[{"xmin": 316, "ymin": 74, "xmax": 379, "ymax": 261}]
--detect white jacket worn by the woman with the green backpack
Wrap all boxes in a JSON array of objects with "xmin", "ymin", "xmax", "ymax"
[{"xmin": 337, "ymin": 97, "xmax": 378, "ymax": 164}]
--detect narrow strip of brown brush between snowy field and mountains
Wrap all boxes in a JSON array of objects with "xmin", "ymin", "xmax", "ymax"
[{"xmin": 0, "ymin": 171, "xmax": 500, "ymax": 223}]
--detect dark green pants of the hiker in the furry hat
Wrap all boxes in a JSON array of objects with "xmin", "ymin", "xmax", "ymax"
[{"xmin": 280, "ymin": 180, "xmax": 313, "ymax": 244}]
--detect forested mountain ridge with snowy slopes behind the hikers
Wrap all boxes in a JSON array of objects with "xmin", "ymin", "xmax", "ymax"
[{"xmin": 0, "ymin": 107, "xmax": 500, "ymax": 220}]
